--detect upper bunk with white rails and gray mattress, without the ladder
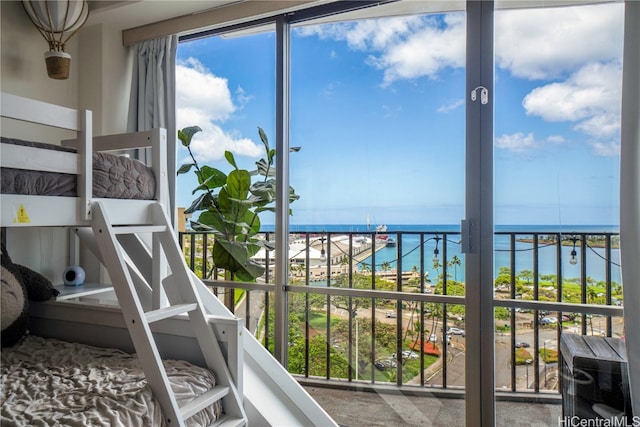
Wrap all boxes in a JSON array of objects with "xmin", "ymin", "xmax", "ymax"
[{"xmin": 1, "ymin": 93, "xmax": 168, "ymax": 227}]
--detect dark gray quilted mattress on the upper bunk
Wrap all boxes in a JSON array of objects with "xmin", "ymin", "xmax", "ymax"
[{"xmin": 2, "ymin": 137, "xmax": 156, "ymax": 200}]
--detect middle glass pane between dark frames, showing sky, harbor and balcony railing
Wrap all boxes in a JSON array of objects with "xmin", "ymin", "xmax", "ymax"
[{"xmin": 289, "ymin": 2, "xmax": 466, "ymax": 418}]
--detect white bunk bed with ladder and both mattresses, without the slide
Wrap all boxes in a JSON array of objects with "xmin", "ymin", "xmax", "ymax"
[{"xmin": 0, "ymin": 93, "xmax": 246, "ymax": 425}]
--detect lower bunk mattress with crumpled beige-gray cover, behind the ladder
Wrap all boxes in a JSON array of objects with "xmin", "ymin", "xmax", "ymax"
[{"xmin": 0, "ymin": 335, "xmax": 222, "ymax": 427}]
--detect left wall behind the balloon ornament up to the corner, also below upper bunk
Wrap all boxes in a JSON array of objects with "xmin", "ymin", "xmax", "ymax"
[{"xmin": 0, "ymin": 1, "xmax": 84, "ymax": 283}]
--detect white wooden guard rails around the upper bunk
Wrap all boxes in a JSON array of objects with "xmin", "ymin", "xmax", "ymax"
[{"xmin": 0, "ymin": 92, "xmax": 169, "ymax": 227}]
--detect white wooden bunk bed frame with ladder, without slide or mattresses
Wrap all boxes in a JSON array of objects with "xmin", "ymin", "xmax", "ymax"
[{"xmin": 0, "ymin": 93, "xmax": 247, "ymax": 426}]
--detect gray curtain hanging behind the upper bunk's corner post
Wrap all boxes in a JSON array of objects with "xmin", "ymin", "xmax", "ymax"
[{"xmin": 127, "ymin": 35, "xmax": 178, "ymax": 224}]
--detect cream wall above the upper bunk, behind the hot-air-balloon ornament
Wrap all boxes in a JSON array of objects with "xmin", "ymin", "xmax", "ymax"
[{"xmin": 0, "ymin": 1, "xmax": 131, "ymax": 135}]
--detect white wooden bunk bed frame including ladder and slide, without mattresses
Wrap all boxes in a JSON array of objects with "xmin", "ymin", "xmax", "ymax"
[{"xmin": 0, "ymin": 93, "xmax": 337, "ymax": 427}]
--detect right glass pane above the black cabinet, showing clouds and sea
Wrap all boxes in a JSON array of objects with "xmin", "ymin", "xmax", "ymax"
[{"xmin": 494, "ymin": 3, "xmax": 624, "ymax": 425}]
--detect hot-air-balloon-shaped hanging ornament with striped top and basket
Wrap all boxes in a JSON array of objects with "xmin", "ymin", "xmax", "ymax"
[{"xmin": 22, "ymin": 0, "xmax": 89, "ymax": 80}]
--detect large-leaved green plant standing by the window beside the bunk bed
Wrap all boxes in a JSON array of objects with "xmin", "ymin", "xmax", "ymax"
[{"xmin": 178, "ymin": 126, "xmax": 300, "ymax": 290}]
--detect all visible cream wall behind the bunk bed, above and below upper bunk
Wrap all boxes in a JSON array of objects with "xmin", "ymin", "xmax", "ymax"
[{"xmin": 0, "ymin": 1, "xmax": 131, "ymax": 283}]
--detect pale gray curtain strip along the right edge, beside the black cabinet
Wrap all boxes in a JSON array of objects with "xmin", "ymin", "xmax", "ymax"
[{"xmin": 620, "ymin": 0, "xmax": 640, "ymax": 414}]
